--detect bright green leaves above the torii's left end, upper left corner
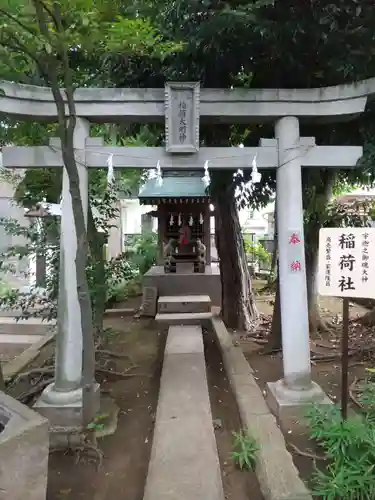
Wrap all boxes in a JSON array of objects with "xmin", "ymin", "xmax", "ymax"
[{"xmin": 0, "ymin": 0, "xmax": 182, "ymax": 86}]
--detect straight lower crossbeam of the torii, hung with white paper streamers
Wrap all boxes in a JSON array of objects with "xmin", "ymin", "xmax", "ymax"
[{"xmin": 3, "ymin": 143, "xmax": 363, "ymax": 170}]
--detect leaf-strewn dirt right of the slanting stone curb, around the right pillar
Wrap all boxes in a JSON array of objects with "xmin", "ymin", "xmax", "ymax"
[{"xmin": 241, "ymin": 286, "xmax": 375, "ymax": 488}]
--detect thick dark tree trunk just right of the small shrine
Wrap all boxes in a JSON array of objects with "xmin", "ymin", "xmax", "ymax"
[{"xmin": 214, "ymin": 184, "xmax": 258, "ymax": 331}]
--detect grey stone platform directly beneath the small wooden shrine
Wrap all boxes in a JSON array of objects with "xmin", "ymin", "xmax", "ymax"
[{"xmin": 142, "ymin": 264, "xmax": 221, "ymax": 307}]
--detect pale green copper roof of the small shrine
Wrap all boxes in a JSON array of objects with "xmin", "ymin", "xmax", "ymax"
[{"xmin": 138, "ymin": 176, "xmax": 208, "ymax": 199}]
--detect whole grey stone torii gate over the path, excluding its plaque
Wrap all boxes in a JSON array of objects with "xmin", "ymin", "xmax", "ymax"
[{"xmin": 0, "ymin": 80, "xmax": 375, "ymax": 424}]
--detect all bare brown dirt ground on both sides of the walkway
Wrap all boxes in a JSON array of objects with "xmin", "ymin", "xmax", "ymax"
[{"xmin": 6, "ymin": 283, "xmax": 375, "ymax": 500}]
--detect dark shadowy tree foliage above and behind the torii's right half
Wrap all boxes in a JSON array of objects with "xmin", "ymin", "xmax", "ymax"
[{"xmin": 102, "ymin": 0, "xmax": 375, "ymax": 211}]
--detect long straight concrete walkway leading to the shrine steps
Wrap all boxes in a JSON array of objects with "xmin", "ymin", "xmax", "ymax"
[{"xmin": 143, "ymin": 326, "xmax": 224, "ymax": 500}]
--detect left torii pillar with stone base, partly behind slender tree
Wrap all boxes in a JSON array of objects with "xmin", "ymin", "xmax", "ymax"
[{"xmin": 34, "ymin": 118, "xmax": 100, "ymax": 426}]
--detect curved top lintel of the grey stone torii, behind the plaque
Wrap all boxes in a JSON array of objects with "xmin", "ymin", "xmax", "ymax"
[{"xmin": 0, "ymin": 78, "xmax": 375, "ymax": 124}]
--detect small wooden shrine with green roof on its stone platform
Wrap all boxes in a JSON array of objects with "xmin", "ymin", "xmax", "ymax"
[{"xmin": 138, "ymin": 170, "xmax": 221, "ymax": 305}]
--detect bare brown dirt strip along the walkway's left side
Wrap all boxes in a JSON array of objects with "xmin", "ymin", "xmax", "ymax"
[{"xmin": 47, "ymin": 317, "xmax": 166, "ymax": 500}]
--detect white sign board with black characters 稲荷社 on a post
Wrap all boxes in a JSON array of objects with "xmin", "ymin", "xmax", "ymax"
[{"xmin": 318, "ymin": 227, "xmax": 375, "ymax": 298}]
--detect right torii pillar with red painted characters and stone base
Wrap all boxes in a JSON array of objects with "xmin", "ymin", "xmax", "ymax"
[{"xmin": 268, "ymin": 116, "xmax": 330, "ymax": 418}]
